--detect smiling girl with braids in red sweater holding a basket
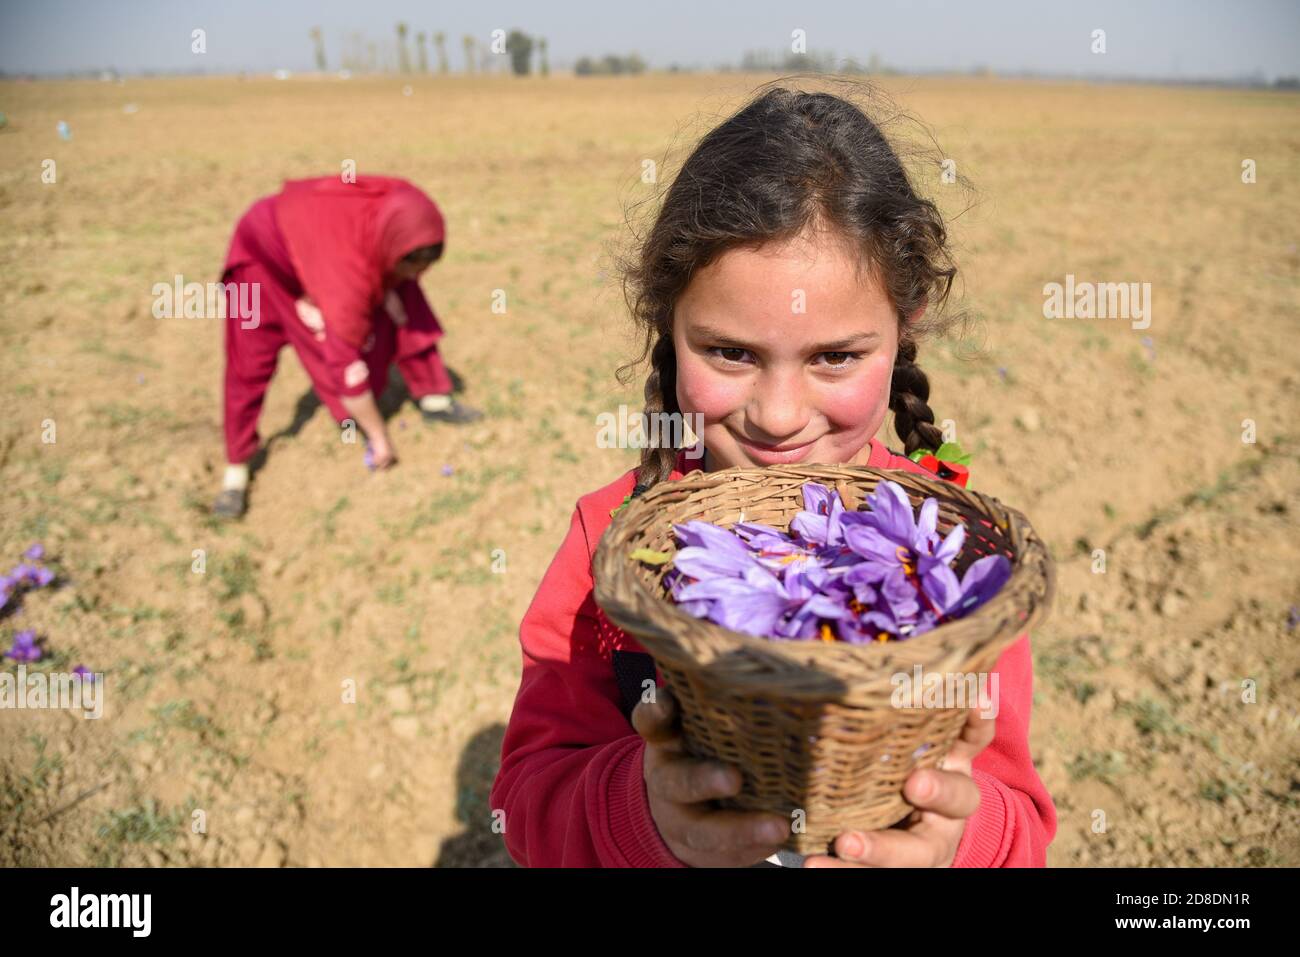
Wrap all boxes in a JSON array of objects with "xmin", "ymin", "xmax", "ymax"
[{"xmin": 491, "ymin": 88, "xmax": 1056, "ymax": 867}]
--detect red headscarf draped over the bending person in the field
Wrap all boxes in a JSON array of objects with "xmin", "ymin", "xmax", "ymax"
[{"xmin": 274, "ymin": 176, "xmax": 446, "ymax": 347}]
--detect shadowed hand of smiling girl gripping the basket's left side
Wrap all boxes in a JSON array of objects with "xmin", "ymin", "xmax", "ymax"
[{"xmin": 632, "ymin": 688, "xmax": 790, "ymax": 867}]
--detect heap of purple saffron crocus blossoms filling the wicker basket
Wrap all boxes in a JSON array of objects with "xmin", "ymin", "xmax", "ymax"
[{"xmin": 663, "ymin": 481, "xmax": 1011, "ymax": 644}]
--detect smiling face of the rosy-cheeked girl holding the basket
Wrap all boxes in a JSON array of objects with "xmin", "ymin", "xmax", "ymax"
[{"xmin": 672, "ymin": 231, "xmax": 919, "ymax": 471}]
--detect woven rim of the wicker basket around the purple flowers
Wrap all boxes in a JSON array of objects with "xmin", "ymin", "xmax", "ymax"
[{"xmin": 593, "ymin": 463, "xmax": 1054, "ymax": 681}]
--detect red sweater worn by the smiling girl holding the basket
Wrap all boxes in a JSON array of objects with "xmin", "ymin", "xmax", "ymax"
[{"xmin": 490, "ymin": 439, "xmax": 1057, "ymax": 867}]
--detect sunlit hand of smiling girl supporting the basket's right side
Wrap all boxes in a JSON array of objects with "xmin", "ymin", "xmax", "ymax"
[{"xmin": 803, "ymin": 707, "xmax": 997, "ymax": 867}]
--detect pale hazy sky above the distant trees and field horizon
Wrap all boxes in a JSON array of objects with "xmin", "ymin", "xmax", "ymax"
[{"xmin": 0, "ymin": 0, "xmax": 1300, "ymax": 82}]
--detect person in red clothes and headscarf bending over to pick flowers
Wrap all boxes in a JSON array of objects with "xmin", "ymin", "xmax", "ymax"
[{"xmin": 213, "ymin": 176, "xmax": 481, "ymax": 518}]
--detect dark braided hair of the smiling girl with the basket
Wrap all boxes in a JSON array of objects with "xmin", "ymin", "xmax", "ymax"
[{"xmin": 618, "ymin": 78, "xmax": 970, "ymax": 494}]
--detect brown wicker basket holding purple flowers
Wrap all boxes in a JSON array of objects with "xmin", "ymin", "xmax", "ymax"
[{"xmin": 593, "ymin": 465, "xmax": 1054, "ymax": 854}]
